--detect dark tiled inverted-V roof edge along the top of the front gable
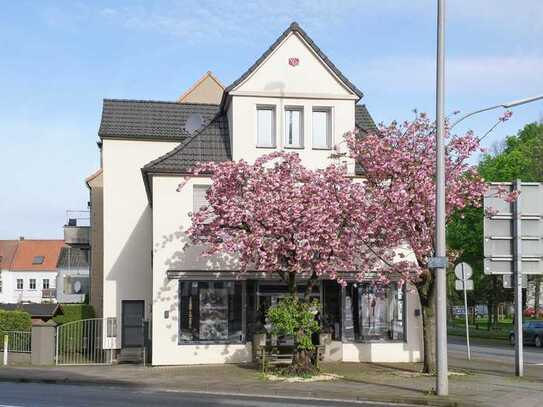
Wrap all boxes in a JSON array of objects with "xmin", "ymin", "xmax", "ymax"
[{"xmin": 223, "ymin": 22, "xmax": 364, "ymax": 98}]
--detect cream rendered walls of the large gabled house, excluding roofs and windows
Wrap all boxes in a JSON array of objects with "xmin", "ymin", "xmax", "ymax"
[{"xmin": 102, "ymin": 22, "xmax": 428, "ymax": 365}]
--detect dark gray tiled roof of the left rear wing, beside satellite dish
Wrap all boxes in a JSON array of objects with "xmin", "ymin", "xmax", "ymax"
[{"xmin": 98, "ymin": 99, "xmax": 219, "ymax": 140}]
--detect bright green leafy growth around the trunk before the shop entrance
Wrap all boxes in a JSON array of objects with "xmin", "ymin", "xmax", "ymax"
[{"xmin": 267, "ymin": 296, "xmax": 320, "ymax": 351}]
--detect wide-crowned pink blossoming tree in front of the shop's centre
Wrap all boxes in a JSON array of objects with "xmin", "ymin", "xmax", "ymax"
[{"xmin": 187, "ymin": 152, "xmax": 408, "ymax": 372}]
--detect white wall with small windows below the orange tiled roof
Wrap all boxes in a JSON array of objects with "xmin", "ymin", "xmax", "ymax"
[{"xmin": 0, "ymin": 270, "xmax": 57, "ymax": 304}]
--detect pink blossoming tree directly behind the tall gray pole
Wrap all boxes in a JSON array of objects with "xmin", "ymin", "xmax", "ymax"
[{"xmin": 346, "ymin": 114, "xmax": 508, "ymax": 372}]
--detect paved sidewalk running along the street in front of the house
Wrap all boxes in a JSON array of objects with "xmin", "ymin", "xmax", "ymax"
[{"xmin": 0, "ymin": 363, "xmax": 543, "ymax": 407}]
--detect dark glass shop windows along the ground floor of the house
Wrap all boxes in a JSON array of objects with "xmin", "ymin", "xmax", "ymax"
[{"xmin": 179, "ymin": 280, "xmax": 405, "ymax": 344}]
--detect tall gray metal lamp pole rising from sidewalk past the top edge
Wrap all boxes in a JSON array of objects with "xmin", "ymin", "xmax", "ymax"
[{"xmin": 435, "ymin": 0, "xmax": 449, "ymax": 396}]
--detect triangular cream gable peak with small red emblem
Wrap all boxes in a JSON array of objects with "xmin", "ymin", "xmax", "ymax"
[{"xmin": 225, "ymin": 23, "xmax": 362, "ymax": 100}]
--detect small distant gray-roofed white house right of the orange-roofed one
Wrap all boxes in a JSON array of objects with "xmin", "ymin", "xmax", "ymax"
[{"xmin": 56, "ymin": 246, "xmax": 89, "ymax": 304}]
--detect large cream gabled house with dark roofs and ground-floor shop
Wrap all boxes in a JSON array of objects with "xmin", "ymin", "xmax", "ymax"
[{"xmin": 91, "ymin": 23, "xmax": 422, "ymax": 365}]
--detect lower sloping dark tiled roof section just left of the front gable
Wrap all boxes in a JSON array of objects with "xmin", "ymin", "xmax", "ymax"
[{"xmin": 142, "ymin": 114, "xmax": 232, "ymax": 173}]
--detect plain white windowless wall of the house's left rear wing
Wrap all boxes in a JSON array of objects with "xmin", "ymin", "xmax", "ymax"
[{"xmin": 102, "ymin": 139, "xmax": 178, "ymax": 348}]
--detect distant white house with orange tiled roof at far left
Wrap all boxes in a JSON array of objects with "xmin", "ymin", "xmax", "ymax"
[{"xmin": 0, "ymin": 238, "xmax": 64, "ymax": 304}]
